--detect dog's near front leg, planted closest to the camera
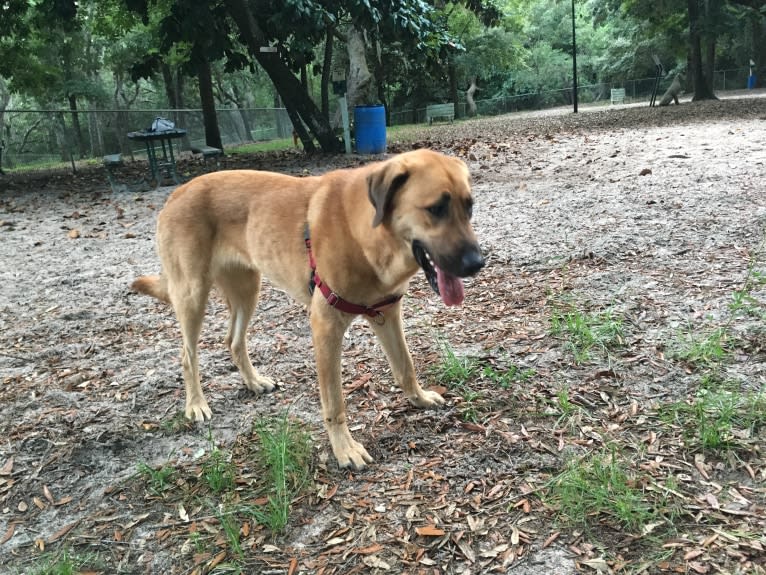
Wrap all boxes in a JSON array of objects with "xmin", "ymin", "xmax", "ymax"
[{"xmin": 311, "ymin": 304, "xmax": 372, "ymax": 469}]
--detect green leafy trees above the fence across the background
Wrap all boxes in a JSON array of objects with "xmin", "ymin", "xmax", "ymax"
[{"xmin": 0, "ymin": 0, "xmax": 766, "ymax": 151}]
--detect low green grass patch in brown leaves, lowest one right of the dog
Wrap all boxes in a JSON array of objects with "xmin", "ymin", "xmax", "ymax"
[{"xmin": 545, "ymin": 450, "xmax": 655, "ymax": 533}]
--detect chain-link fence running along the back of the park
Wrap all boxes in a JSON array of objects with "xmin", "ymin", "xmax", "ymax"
[{"xmin": 0, "ymin": 68, "xmax": 749, "ymax": 171}]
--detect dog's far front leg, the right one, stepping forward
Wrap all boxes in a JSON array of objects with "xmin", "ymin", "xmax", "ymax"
[{"xmin": 369, "ymin": 302, "xmax": 444, "ymax": 407}]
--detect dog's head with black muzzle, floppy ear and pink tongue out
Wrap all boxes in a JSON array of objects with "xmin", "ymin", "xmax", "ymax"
[{"xmin": 367, "ymin": 150, "xmax": 484, "ymax": 305}]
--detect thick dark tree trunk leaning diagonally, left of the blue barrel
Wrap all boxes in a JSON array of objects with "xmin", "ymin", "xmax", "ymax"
[{"xmin": 225, "ymin": 0, "xmax": 342, "ymax": 153}]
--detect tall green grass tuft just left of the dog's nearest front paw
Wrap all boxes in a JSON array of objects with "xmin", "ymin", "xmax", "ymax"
[{"xmin": 252, "ymin": 414, "xmax": 311, "ymax": 534}]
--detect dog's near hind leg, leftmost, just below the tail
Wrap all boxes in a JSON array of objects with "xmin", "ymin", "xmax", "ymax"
[{"xmin": 169, "ymin": 276, "xmax": 213, "ymax": 421}]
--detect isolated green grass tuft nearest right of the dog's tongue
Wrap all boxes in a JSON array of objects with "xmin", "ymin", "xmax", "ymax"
[{"xmin": 550, "ymin": 306, "xmax": 624, "ymax": 364}]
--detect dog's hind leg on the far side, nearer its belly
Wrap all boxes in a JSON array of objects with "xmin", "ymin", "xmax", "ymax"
[{"xmin": 216, "ymin": 268, "xmax": 274, "ymax": 393}]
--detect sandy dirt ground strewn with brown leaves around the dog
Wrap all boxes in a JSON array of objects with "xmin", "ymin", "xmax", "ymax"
[{"xmin": 0, "ymin": 95, "xmax": 766, "ymax": 574}]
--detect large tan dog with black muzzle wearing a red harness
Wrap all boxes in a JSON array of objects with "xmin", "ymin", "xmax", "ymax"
[{"xmin": 132, "ymin": 150, "xmax": 484, "ymax": 469}]
